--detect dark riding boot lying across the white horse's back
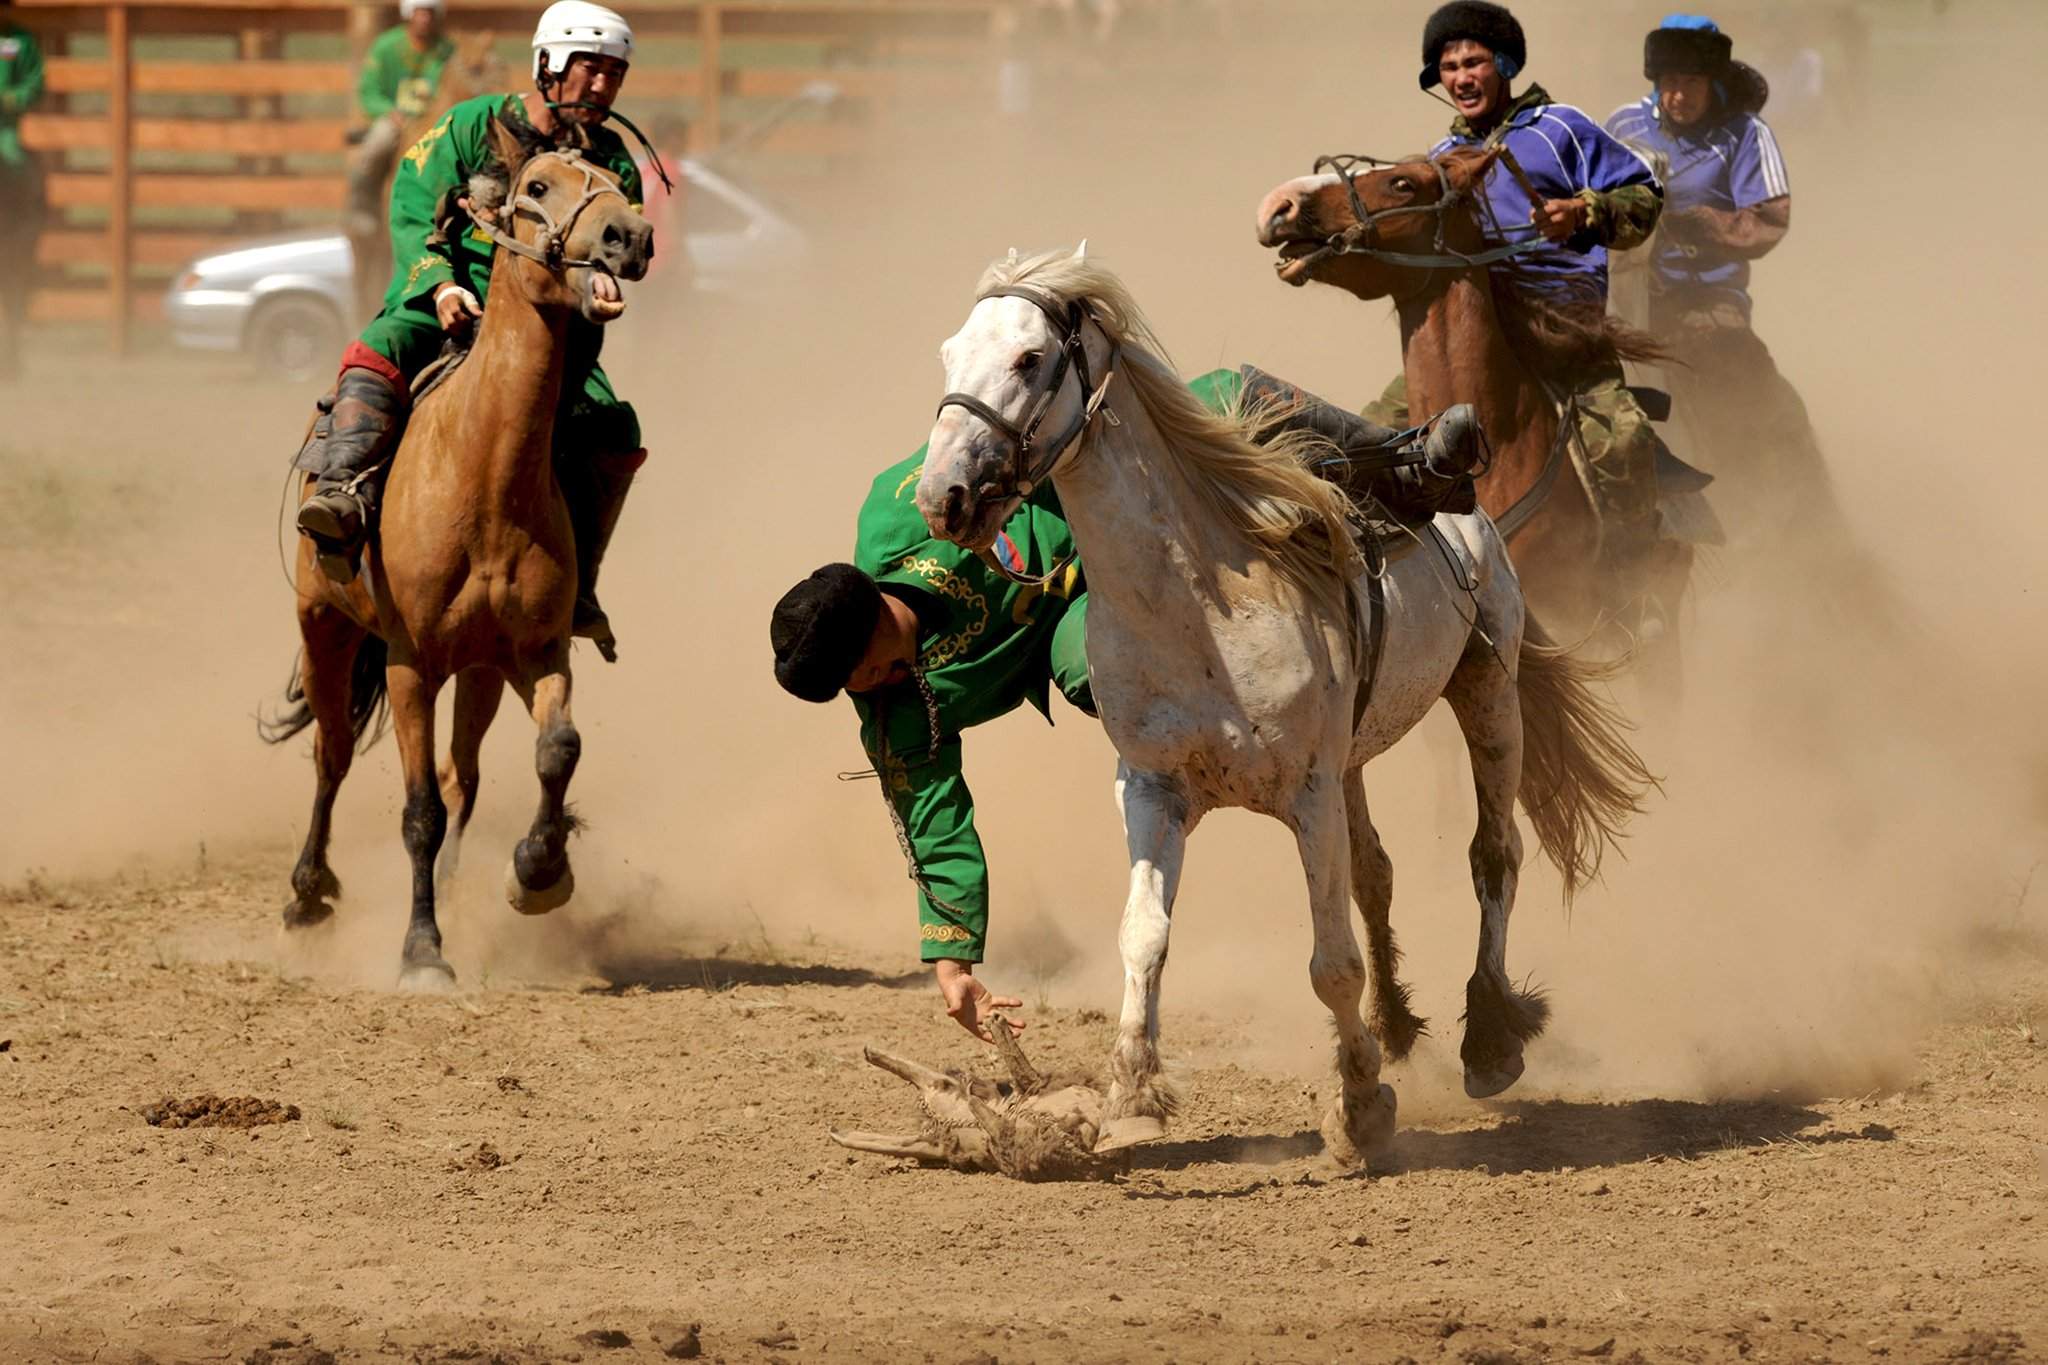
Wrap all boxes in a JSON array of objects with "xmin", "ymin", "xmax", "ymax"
[{"xmin": 1239, "ymin": 364, "xmax": 1485, "ymax": 518}]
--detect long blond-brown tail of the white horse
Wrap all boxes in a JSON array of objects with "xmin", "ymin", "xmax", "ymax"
[{"xmin": 1516, "ymin": 616, "xmax": 1657, "ymax": 905}]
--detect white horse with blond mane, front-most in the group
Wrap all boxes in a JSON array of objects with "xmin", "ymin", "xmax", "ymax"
[{"xmin": 918, "ymin": 244, "xmax": 1651, "ymax": 1162}]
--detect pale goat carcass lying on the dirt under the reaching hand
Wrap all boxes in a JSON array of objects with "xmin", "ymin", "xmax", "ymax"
[{"xmin": 831, "ymin": 1015, "xmax": 1155, "ymax": 1179}]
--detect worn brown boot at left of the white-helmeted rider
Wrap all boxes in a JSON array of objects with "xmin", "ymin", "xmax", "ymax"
[{"xmin": 295, "ymin": 366, "xmax": 406, "ymax": 583}]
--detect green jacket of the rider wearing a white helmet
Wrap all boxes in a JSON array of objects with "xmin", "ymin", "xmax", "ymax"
[{"xmin": 383, "ymin": 94, "xmax": 641, "ymax": 317}]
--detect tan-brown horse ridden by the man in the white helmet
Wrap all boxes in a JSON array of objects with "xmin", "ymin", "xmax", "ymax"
[{"xmin": 264, "ymin": 123, "xmax": 653, "ymax": 988}]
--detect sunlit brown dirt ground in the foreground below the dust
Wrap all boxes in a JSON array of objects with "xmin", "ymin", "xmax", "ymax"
[{"xmin": 0, "ymin": 851, "xmax": 2048, "ymax": 1365}]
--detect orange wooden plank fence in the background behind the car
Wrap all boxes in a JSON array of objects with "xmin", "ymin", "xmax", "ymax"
[{"xmin": 14, "ymin": 0, "xmax": 993, "ymax": 350}]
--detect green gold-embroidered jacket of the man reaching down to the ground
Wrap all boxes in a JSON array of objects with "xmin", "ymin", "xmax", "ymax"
[{"xmin": 854, "ymin": 448, "xmax": 1087, "ymax": 962}]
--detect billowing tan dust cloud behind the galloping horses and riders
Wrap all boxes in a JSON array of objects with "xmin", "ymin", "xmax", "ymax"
[{"xmin": 0, "ymin": 2, "xmax": 2048, "ymax": 1115}]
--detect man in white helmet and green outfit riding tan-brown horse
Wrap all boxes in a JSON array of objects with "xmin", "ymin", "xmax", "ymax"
[{"xmin": 297, "ymin": 0, "xmax": 647, "ymax": 659}]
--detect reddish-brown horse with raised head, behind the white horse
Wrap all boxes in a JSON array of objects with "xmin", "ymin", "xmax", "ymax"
[{"xmin": 1257, "ymin": 147, "xmax": 1692, "ymax": 692}]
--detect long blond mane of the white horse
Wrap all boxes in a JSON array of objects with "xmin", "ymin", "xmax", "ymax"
[{"xmin": 975, "ymin": 250, "xmax": 1358, "ymax": 591}]
